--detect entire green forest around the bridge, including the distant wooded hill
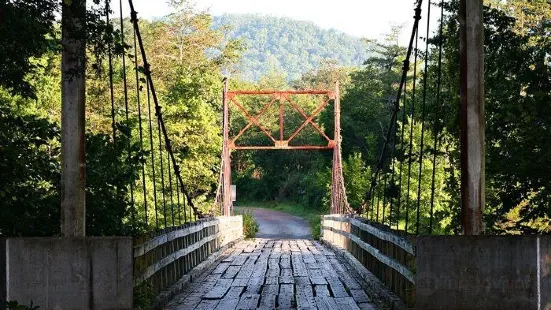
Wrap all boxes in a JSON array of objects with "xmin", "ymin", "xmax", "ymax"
[{"xmin": 0, "ymin": 0, "xmax": 551, "ymax": 236}]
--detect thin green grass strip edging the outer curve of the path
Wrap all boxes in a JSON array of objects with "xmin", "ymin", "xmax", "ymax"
[{"xmin": 240, "ymin": 201, "xmax": 322, "ymax": 240}]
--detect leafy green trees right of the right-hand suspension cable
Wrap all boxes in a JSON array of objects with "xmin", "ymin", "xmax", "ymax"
[{"xmin": 363, "ymin": 0, "xmax": 551, "ymax": 234}]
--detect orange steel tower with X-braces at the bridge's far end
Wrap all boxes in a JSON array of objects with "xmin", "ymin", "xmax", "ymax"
[{"xmin": 215, "ymin": 80, "xmax": 351, "ymax": 215}]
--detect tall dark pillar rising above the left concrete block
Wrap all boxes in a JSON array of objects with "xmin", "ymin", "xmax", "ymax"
[{"xmin": 61, "ymin": 0, "xmax": 86, "ymax": 237}]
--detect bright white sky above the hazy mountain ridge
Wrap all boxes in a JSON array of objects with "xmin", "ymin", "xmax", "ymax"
[{"xmin": 115, "ymin": 0, "xmax": 437, "ymax": 45}]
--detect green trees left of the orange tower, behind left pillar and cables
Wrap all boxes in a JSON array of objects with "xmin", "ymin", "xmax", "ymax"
[{"xmin": 0, "ymin": 1, "xmax": 239, "ymax": 236}]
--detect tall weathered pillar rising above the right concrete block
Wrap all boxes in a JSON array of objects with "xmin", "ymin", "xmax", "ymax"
[{"xmin": 460, "ymin": 0, "xmax": 484, "ymax": 235}]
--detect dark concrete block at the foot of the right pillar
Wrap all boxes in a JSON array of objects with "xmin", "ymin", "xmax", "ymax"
[{"xmin": 416, "ymin": 236, "xmax": 551, "ymax": 310}]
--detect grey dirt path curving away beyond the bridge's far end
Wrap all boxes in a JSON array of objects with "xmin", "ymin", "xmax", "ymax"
[{"xmin": 242, "ymin": 208, "xmax": 312, "ymax": 239}]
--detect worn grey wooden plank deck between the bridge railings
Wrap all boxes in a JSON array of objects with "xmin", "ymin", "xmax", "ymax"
[{"xmin": 165, "ymin": 239, "xmax": 376, "ymax": 310}]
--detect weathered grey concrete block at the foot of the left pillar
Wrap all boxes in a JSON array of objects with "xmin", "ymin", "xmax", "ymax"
[{"xmin": 0, "ymin": 237, "xmax": 133, "ymax": 309}]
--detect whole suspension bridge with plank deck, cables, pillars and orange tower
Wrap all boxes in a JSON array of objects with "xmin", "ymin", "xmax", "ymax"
[{"xmin": 0, "ymin": 0, "xmax": 551, "ymax": 310}]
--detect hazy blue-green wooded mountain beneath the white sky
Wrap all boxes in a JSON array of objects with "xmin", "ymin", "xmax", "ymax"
[{"xmin": 213, "ymin": 14, "xmax": 367, "ymax": 81}]
